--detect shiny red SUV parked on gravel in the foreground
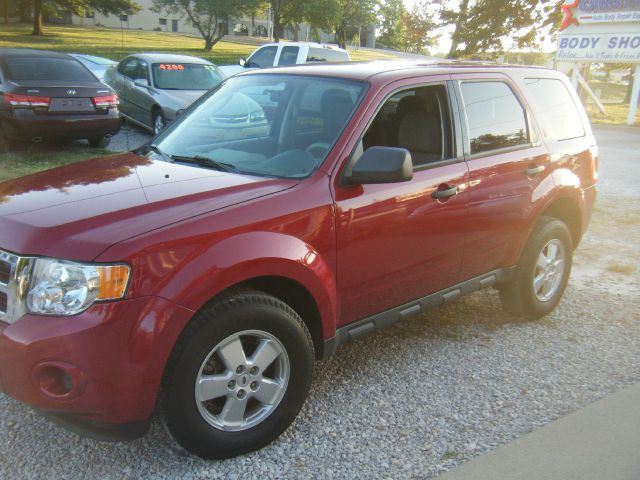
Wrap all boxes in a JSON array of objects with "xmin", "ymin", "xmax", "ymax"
[{"xmin": 0, "ymin": 62, "xmax": 598, "ymax": 458}]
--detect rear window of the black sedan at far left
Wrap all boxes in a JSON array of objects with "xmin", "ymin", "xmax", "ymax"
[{"xmin": 5, "ymin": 57, "xmax": 96, "ymax": 82}]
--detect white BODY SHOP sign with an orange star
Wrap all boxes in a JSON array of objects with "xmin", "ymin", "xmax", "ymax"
[{"xmin": 556, "ymin": 0, "xmax": 640, "ymax": 63}]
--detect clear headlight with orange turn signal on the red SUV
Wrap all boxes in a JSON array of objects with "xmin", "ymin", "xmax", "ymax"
[{"xmin": 25, "ymin": 258, "xmax": 130, "ymax": 315}]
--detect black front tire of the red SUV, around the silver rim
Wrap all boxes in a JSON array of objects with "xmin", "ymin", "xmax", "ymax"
[{"xmin": 160, "ymin": 290, "xmax": 314, "ymax": 459}]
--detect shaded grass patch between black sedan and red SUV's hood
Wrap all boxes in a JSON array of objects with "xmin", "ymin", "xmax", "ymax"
[{"xmin": 0, "ymin": 144, "xmax": 112, "ymax": 182}]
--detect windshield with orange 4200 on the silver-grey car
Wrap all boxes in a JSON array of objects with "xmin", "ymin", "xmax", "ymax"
[{"xmin": 152, "ymin": 63, "xmax": 222, "ymax": 90}]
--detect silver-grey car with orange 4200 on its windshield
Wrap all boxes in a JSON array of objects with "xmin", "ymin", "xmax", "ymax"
[{"xmin": 104, "ymin": 53, "xmax": 224, "ymax": 134}]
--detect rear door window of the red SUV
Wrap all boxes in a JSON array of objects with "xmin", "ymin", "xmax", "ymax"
[{"xmin": 460, "ymin": 82, "xmax": 529, "ymax": 154}]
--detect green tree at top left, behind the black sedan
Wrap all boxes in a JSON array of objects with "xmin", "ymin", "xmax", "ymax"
[{"xmin": 26, "ymin": 0, "xmax": 140, "ymax": 35}]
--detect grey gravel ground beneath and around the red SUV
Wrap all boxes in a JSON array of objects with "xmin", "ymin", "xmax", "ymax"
[{"xmin": 0, "ymin": 127, "xmax": 640, "ymax": 479}]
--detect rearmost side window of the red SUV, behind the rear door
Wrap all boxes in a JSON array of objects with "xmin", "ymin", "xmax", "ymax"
[{"xmin": 525, "ymin": 78, "xmax": 584, "ymax": 140}]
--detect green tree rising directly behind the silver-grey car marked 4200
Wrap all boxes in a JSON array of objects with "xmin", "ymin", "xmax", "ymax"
[{"xmin": 153, "ymin": 0, "xmax": 242, "ymax": 51}]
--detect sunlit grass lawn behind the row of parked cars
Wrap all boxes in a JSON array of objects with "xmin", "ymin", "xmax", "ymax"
[{"xmin": 0, "ymin": 24, "xmax": 393, "ymax": 64}]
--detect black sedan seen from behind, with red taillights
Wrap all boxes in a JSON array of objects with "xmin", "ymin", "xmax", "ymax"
[{"xmin": 0, "ymin": 48, "xmax": 120, "ymax": 147}]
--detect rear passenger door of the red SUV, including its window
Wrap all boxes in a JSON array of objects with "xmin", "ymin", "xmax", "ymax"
[{"xmin": 452, "ymin": 74, "xmax": 552, "ymax": 278}]
